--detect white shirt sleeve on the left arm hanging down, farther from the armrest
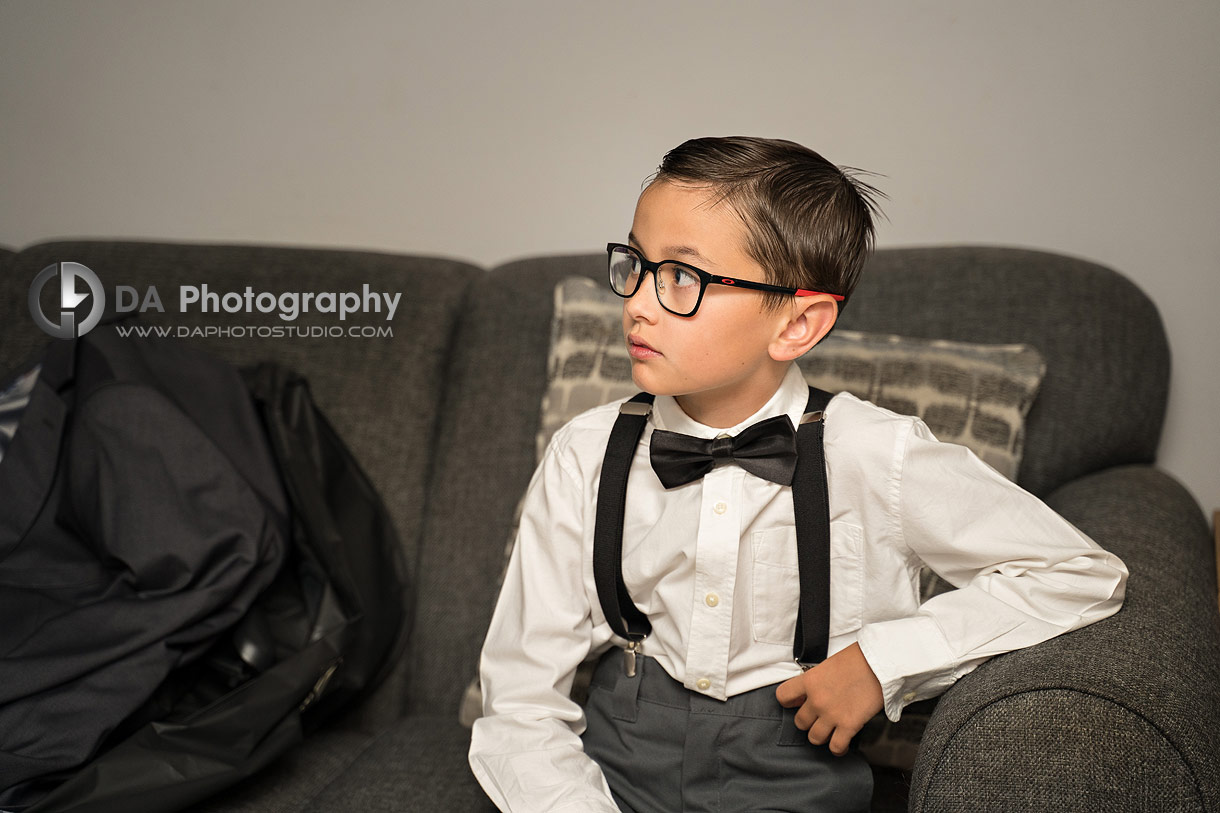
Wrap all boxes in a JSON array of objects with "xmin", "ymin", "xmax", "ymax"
[{"xmin": 470, "ymin": 432, "xmax": 619, "ymax": 813}]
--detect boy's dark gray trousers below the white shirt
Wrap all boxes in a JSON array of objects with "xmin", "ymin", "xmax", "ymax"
[{"xmin": 581, "ymin": 647, "xmax": 872, "ymax": 813}]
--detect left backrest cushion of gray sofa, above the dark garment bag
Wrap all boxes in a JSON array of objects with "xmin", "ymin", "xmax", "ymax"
[{"xmin": 0, "ymin": 242, "xmax": 486, "ymax": 720}]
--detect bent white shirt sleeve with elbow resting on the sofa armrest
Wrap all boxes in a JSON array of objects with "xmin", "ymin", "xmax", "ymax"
[{"xmin": 859, "ymin": 420, "xmax": 1127, "ymax": 720}]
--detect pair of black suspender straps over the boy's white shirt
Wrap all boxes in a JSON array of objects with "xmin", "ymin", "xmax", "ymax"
[{"xmin": 593, "ymin": 387, "xmax": 832, "ymax": 675}]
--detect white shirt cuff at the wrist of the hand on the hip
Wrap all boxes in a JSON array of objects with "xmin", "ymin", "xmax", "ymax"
[{"xmin": 856, "ymin": 615, "xmax": 955, "ymax": 723}]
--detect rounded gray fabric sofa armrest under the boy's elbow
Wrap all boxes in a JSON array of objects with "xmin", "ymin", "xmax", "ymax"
[{"xmin": 910, "ymin": 466, "xmax": 1220, "ymax": 813}]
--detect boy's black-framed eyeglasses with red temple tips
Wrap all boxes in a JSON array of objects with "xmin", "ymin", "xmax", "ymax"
[{"xmin": 606, "ymin": 243, "xmax": 844, "ymax": 316}]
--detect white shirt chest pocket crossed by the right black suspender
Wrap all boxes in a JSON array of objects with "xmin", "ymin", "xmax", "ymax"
[{"xmin": 750, "ymin": 522, "xmax": 864, "ymax": 647}]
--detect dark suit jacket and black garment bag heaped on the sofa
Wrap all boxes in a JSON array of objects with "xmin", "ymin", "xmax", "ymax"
[{"xmin": 0, "ymin": 328, "xmax": 406, "ymax": 813}]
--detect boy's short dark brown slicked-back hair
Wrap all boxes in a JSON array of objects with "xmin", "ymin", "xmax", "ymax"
[{"xmin": 647, "ymin": 136, "xmax": 885, "ymax": 308}]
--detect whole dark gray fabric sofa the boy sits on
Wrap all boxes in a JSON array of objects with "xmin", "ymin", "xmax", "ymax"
[{"xmin": 0, "ymin": 242, "xmax": 1220, "ymax": 813}]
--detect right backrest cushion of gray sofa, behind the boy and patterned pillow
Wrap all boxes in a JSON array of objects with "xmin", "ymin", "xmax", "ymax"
[{"xmin": 422, "ymin": 247, "xmax": 1169, "ymax": 709}]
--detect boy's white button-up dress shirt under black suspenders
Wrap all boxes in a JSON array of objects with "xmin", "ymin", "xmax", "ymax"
[{"xmin": 470, "ymin": 365, "xmax": 1127, "ymax": 813}]
